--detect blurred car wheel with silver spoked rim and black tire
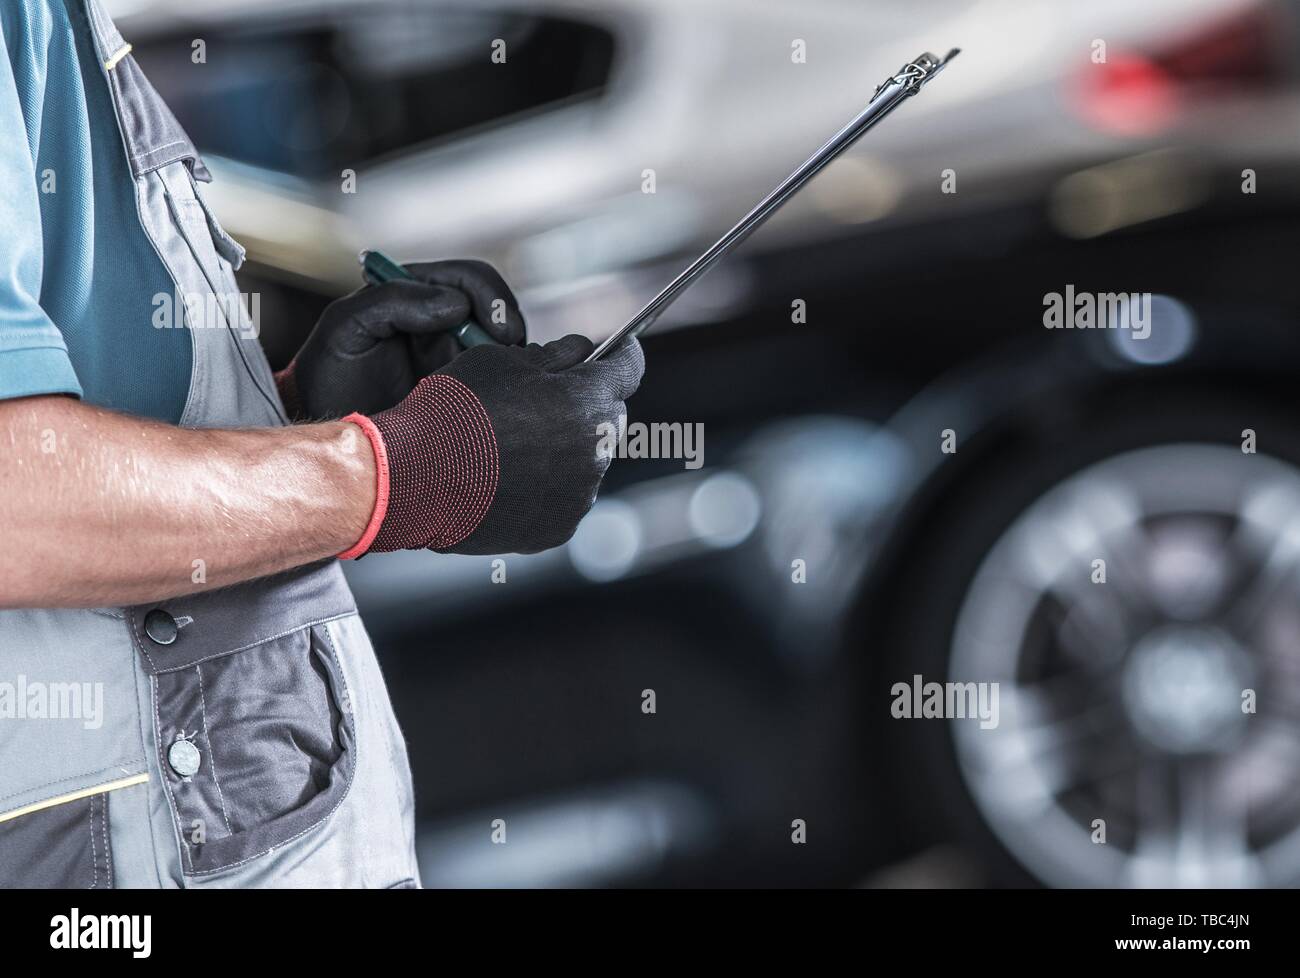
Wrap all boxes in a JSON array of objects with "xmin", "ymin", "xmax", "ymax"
[{"xmin": 874, "ymin": 384, "xmax": 1300, "ymax": 887}]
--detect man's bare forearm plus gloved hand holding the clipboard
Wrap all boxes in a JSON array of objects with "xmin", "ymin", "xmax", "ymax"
[{"xmin": 0, "ymin": 336, "xmax": 645, "ymax": 607}]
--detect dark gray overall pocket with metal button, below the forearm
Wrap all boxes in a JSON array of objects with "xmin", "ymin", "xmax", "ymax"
[{"xmin": 129, "ymin": 562, "xmax": 356, "ymax": 875}]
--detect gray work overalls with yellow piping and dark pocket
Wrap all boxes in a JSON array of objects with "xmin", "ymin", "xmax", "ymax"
[{"xmin": 0, "ymin": 0, "xmax": 419, "ymax": 888}]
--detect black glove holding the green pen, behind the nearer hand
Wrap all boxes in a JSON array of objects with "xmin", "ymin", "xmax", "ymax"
[{"xmin": 276, "ymin": 261, "xmax": 524, "ymax": 420}]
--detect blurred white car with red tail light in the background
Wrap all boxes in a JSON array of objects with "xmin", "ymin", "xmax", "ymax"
[{"xmin": 118, "ymin": 0, "xmax": 1296, "ymax": 342}]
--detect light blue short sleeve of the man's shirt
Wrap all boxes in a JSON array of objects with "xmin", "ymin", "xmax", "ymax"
[{"xmin": 0, "ymin": 0, "xmax": 82, "ymax": 399}]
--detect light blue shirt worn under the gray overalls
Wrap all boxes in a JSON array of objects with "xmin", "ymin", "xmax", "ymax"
[{"xmin": 0, "ymin": 0, "xmax": 192, "ymax": 423}]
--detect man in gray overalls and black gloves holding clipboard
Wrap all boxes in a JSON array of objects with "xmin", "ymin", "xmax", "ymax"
[{"xmin": 0, "ymin": 0, "xmax": 642, "ymax": 887}]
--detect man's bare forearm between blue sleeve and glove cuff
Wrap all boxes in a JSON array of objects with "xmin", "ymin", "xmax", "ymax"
[{"xmin": 0, "ymin": 397, "xmax": 376, "ymax": 607}]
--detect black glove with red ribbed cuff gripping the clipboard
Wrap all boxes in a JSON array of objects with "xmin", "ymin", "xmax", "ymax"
[{"xmin": 341, "ymin": 336, "xmax": 645, "ymax": 557}]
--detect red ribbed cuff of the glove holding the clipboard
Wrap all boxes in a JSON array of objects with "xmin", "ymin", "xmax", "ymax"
[{"xmin": 341, "ymin": 373, "xmax": 501, "ymax": 557}]
